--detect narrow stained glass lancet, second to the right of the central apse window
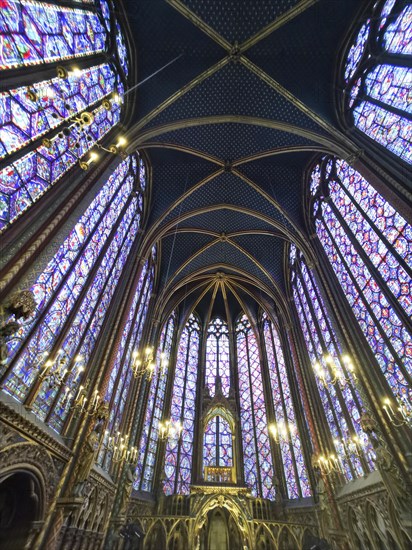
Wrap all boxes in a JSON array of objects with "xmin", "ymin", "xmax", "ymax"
[{"xmin": 263, "ymin": 314, "xmax": 311, "ymax": 498}]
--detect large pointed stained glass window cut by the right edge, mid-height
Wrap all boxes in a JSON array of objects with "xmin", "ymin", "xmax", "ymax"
[{"xmin": 310, "ymin": 156, "xmax": 412, "ymax": 407}]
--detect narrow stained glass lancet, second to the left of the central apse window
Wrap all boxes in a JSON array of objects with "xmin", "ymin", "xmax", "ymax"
[{"xmin": 134, "ymin": 313, "xmax": 176, "ymax": 491}]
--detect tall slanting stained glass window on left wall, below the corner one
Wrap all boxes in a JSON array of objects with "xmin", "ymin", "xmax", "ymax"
[{"xmin": 3, "ymin": 155, "xmax": 143, "ymax": 430}]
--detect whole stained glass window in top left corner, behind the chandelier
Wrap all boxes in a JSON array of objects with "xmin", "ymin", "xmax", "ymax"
[{"xmin": 0, "ymin": 0, "xmax": 128, "ymax": 232}]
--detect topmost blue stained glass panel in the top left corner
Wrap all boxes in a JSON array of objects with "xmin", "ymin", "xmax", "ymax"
[{"xmin": 0, "ymin": 0, "xmax": 107, "ymax": 70}]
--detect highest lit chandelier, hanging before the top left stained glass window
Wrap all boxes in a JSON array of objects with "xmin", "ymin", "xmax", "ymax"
[{"xmin": 27, "ymin": 66, "xmax": 126, "ymax": 170}]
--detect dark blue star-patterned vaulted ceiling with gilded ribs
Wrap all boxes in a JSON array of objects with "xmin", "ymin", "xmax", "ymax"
[{"xmin": 124, "ymin": 0, "xmax": 367, "ymax": 322}]
